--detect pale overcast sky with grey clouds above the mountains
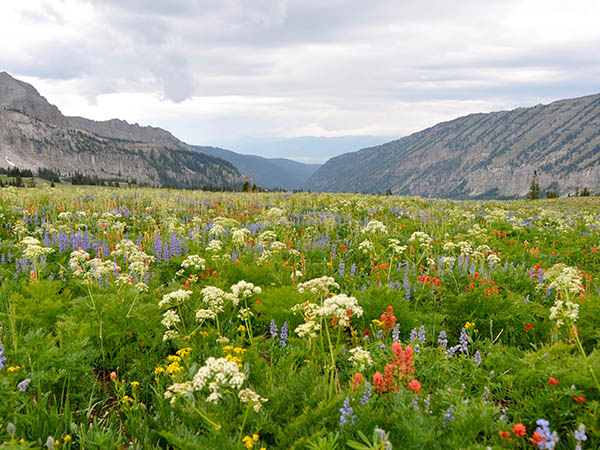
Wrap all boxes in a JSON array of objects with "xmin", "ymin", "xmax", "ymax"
[{"xmin": 0, "ymin": 0, "xmax": 600, "ymax": 162}]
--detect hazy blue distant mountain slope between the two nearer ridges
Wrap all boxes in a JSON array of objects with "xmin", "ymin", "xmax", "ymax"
[{"xmin": 193, "ymin": 145, "xmax": 321, "ymax": 191}]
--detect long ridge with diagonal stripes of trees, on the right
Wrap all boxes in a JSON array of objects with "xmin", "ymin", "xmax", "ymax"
[{"xmin": 307, "ymin": 94, "xmax": 600, "ymax": 198}]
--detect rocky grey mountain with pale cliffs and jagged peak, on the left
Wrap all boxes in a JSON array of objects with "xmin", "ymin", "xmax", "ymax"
[{"xmin": 0, "ymin": 72, "xmax": 249, "ymax": 187}]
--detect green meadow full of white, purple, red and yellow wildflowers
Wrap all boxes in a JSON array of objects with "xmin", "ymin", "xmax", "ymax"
[{"xmin": 0, "ymin": 186, "xmax": 600, "ymax": 450}]
